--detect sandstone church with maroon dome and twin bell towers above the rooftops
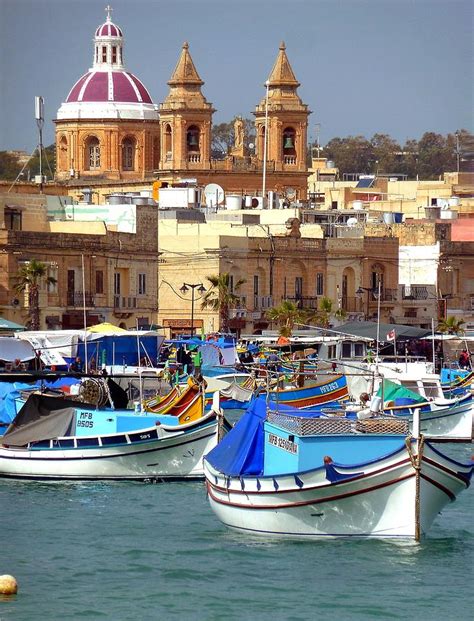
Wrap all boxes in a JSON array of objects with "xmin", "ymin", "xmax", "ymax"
[{"xmin": 55, "ymin": 9, "xmax": 310, "ymax": 199}]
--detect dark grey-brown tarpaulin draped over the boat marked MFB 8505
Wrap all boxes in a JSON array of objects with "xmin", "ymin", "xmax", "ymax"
[{"xmin": 2, "ymin": 394, "xmax": 82, "ymax": 446}]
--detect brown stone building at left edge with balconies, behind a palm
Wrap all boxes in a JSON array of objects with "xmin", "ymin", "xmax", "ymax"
[{"xmin": 0, "ymin": 194, "xmax": 158, "ymax": 329}]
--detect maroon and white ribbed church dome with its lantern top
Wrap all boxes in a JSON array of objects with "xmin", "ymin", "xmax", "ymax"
[{"xmin": 57, "ymin": 7, "xmax": 158, "ymax": 120}]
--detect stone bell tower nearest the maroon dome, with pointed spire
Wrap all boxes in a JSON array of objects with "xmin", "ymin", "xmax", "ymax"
[{"xmin": 160, "ymin": 43, "xmax": 214, "ymax": 171}]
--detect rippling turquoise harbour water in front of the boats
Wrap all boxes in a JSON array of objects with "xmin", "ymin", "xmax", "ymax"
[{"xmin": 0, "ymin": 447, "xmax": 474, "ymax": 621}]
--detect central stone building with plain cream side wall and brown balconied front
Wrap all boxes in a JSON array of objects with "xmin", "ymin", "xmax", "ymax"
[{"xmin": 159, "ymin": 209, "xmax": 398, "ymax": 335}]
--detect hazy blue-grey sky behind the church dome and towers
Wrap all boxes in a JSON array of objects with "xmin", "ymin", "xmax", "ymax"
[{"xmin": 0, "ymin": 0, "xmax": 474, "ymax": 152}]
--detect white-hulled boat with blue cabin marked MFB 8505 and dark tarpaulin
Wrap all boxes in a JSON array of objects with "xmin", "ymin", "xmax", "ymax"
[{"xmin": 0, "ymin": 394, "xmax": 225, "ymax": 481}]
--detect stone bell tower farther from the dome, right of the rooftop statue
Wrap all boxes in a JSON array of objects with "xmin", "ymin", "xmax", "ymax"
[{"xmin": 254, "ymin": 42, "xmax": 311, "ymax": 172}]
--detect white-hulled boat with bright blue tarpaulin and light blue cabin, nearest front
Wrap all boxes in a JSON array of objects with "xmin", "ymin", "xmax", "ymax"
[{"xmin": 204, "ymin": 399, "xmax": 474, "ymax": 540}]
